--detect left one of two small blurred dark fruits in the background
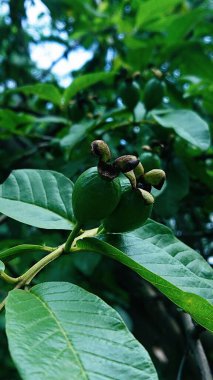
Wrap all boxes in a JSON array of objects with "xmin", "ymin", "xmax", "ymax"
[{"xmin": 119, "ymin": 81, "xmax": 140, "ymax": 111}]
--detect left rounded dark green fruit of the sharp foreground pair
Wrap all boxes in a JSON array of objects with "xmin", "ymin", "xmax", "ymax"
[{"xmin": 72, "ymin": 167, "xmax": 121, "ymax": 229}]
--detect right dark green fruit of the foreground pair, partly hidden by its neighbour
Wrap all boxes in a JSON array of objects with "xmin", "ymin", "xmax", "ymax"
[{"xmin": 103, "ymin": 185, "xmax": 153, "ymax": 232}]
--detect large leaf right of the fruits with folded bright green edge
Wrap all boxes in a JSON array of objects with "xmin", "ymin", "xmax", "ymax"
[{"xmin": 77, "ymin": 221, "xmax": 213, "ymax": 331}]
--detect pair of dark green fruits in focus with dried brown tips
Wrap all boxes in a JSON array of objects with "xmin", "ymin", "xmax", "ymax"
[{"xmin": 72, "ymin": 140, "xmax": 166, "ymax": 232}]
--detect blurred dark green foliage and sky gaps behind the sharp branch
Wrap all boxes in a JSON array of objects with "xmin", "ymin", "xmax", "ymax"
[{"xmin": 0, "ymin": 0, "xmax": 213, "ymax": 380}]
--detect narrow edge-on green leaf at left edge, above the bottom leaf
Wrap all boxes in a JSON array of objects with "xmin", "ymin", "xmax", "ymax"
[{"xmin": 0, "ymin": 244, "xmax": 53, "ymax": 261}]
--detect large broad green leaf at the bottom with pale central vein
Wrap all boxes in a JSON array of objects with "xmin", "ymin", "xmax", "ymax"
[{"xmin": 6, "ymin": 282, "xmax": 157, "ymax": 380}]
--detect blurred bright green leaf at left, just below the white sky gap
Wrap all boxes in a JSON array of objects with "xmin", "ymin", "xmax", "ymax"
[{"xmin": 12, "ymin": 83, "xmax": 62, "ymax": 105}]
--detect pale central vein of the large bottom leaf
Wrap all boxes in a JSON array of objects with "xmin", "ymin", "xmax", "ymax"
[{"xmin": 30, "ymin": 290, "xmax": 89, "ymax": 380}]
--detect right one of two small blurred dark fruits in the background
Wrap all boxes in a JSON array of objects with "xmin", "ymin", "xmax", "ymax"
[{"xmin": 143, "ymin": 78, "xmax": 164, "ymax": 111}]
